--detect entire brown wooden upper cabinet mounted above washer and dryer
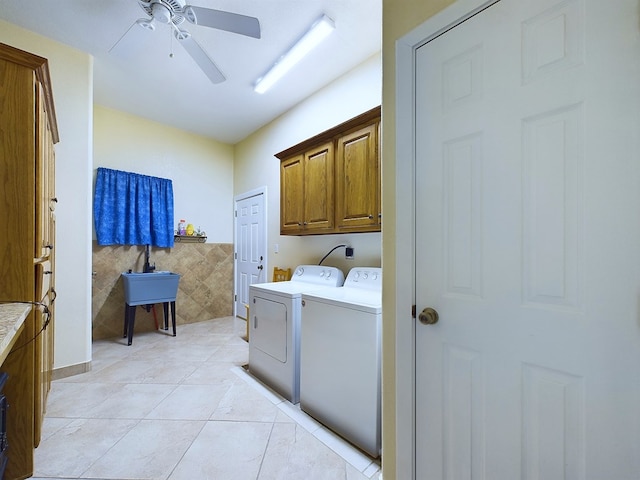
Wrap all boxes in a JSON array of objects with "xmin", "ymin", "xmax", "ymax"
[{"xmin": 276, "ymin": 107, "xmax": 381, "ymax": 235}]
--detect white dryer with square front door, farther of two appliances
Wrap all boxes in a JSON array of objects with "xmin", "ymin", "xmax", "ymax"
[{"xmin": 249, "ymin": 265, "xmax": 344, "ymax": 404}]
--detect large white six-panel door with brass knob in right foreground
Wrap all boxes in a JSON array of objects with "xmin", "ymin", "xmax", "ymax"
[{"xmin": 414, "ymin": 0, "xmax": 640, "ymax": 480}]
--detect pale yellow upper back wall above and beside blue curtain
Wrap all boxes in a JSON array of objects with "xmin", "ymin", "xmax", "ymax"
[{"xmin": 93, "ymin": 105, "xmax": 234, "ymax": 243}]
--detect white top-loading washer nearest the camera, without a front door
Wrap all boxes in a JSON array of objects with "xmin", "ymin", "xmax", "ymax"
[{"xmin": 300, "ymin": 267, "xmax": 382, "ymax": 457}]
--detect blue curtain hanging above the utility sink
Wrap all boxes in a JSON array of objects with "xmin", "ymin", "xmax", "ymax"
[{"xmin": 93, "ymin": 168, "xmax": 174, "ymax": 247}]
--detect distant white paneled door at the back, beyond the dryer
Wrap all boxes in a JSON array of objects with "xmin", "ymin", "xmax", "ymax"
[{"xmin": 234, "ymin": 190, "xmax": 268, "ymax": 318}]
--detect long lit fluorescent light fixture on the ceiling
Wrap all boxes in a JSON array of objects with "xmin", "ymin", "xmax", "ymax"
[{"xmin": 254, "ymin": 15, "xmax": 336, "ymax": 93}]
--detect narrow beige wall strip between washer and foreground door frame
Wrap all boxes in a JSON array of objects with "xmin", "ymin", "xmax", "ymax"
[{"xmin": 382, "ymin": 0, "xmax": 454, "ymax": 480}]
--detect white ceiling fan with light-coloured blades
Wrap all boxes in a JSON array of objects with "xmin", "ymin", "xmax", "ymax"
[{"xmin": 111, "ymin": 0, "xmax": 260, "ymax": 83}]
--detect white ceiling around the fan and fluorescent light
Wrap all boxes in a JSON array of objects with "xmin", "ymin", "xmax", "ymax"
[{"xmin": 0, "ymin": 0, "xmax": 382, "ymax": 143}]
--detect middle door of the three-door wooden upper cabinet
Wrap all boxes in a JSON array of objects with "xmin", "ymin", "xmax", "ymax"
[{"xmin": 303, "ymin": 142, "xmax": 335, "ymax": 233}]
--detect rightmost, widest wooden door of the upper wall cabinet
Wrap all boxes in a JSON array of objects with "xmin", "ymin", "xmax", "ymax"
[{"xmin": 336, "ymin": 123, "xmax": 380, "ymax": 231}]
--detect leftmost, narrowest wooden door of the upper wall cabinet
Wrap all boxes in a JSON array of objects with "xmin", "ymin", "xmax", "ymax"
[{"xmin": 280, "ymin": 155, "xmax": 304, "ymax": 235}]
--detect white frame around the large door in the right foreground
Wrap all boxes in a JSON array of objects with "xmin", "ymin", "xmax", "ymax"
[{"xmin": 395, "ymin": 0, "xmax": 499, "ymax": 479}]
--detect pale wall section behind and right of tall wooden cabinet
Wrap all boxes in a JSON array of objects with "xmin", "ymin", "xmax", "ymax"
[{"xmin": 0, "ymin": 20, "xmax": 93, "ymax": 368}]
